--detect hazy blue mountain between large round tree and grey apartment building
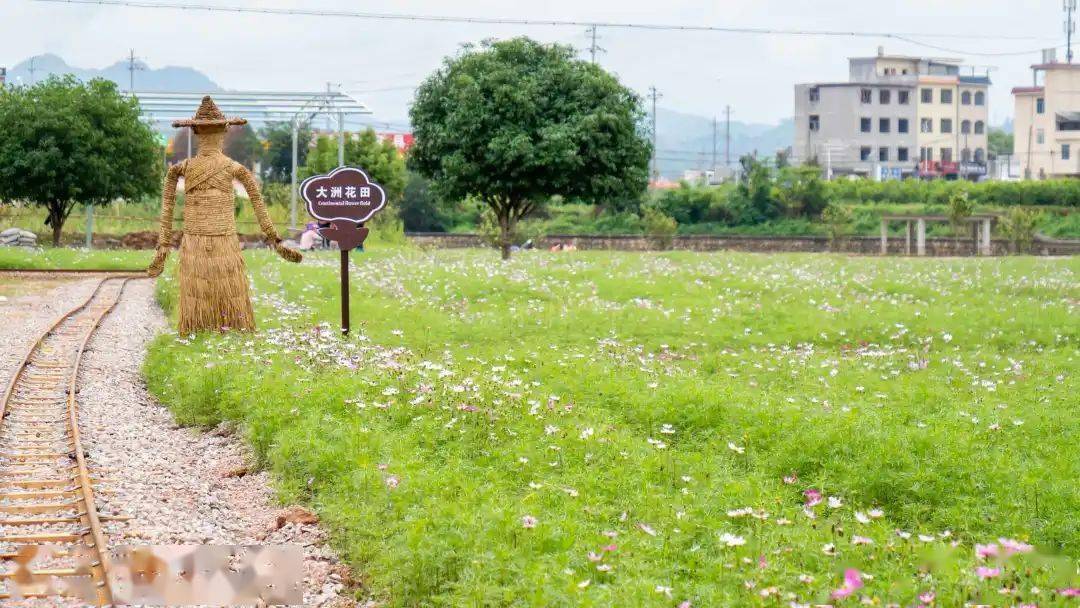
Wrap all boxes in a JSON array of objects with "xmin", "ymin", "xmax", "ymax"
[{"xmin": 657, "ymin": 108, "xmax": 795, "ymax": 178}]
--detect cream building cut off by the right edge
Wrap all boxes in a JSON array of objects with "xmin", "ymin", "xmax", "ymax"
[{"xmin": 1013, "ymin": 56, "xmax": 1080, "ymax": 179}]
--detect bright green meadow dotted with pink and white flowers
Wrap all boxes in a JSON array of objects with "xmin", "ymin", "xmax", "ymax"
[{"xmin": 137, "ymin": 249, "xmax": 1080, "ymax": 607}]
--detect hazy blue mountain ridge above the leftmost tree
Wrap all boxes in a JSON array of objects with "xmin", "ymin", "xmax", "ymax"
[{"xmin": 8, "ymin": 54, "xmax": 222, "ymax": 93}]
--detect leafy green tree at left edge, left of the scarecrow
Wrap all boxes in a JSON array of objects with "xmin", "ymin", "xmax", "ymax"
[{"xmin": 0, "ymin": 76, "xmax": 161, "ymax": 245}]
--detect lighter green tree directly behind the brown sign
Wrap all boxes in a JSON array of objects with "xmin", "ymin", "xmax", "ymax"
[{"xmin": 299, "ymin": 129, "xmax": 406, "ymax": 201}]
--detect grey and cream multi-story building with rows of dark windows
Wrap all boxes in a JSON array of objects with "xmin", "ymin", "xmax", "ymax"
[{"xmin": 792, "ymin": 49, "xmax": 990, "ymax": 179}]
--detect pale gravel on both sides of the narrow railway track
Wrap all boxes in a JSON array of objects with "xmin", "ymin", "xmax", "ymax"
[{"xmin": 0, "ymin": 280, "xmax": 354, "ymax": 608}]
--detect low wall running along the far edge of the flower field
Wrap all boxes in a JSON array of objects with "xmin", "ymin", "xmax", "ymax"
[{"xmin": 407, "ymin": 232, "xmax": 1080, "ymax": 256}]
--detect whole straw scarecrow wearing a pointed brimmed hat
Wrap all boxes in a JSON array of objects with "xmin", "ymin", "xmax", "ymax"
[{"xmin": 147, "ymin": 95, "xmax": 301, "ymax": 334}]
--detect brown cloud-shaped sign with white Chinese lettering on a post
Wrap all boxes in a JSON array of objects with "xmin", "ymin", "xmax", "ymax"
[{"xmin": 300, "ymin": 166, "xmax": 387, "ymax": 336}]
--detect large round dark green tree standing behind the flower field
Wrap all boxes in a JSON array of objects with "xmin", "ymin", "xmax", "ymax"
[{"xmin": 409, "ymin": 38, "xmax": 651, "ymax": 259}]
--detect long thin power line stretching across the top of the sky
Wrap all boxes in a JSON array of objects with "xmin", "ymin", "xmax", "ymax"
[{"xmin": 35, "ymin": 0, "xmax": 1062, "ymax": 47}]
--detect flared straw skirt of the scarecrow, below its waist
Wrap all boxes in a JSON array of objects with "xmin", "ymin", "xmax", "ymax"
[{"xmin": 177, "ymin": 232, "xmax": 255, "ymax": 334}]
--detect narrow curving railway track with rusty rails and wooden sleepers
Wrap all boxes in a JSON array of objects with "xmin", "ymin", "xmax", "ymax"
[{"xmin": 0, "ymin": 276, "xmax": 132, "ymax": 606}]
